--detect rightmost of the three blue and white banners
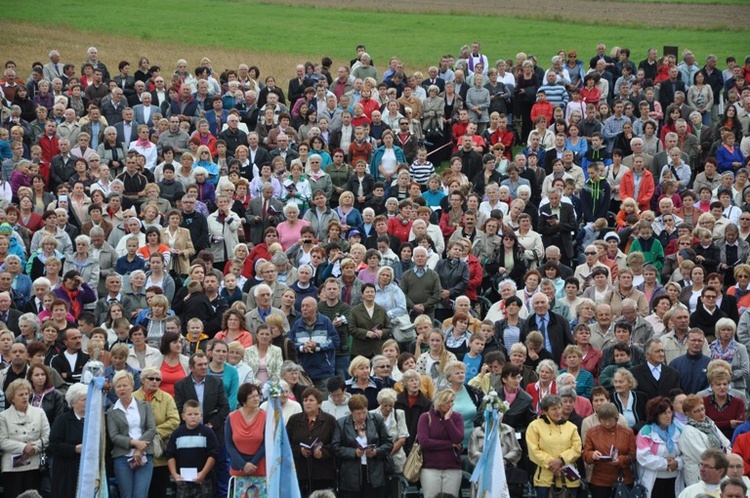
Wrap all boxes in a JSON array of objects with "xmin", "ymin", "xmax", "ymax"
[{"xmin": 471, "ymin": 410, "xmax": 510, "ymax": 498}]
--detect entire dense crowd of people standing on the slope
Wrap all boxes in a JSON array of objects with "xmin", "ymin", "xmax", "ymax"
[{"xmin": 0, "ymin": 42, "xmax": 750, "ymax": 498}]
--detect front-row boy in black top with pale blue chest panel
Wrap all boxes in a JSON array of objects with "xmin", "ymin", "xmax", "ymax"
[{"xmin": 165, "ymin": 399, "xmax": 219, "ymax": 498}]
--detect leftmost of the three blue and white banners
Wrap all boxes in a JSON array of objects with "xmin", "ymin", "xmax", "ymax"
[{"xmin": 78, "ymin": 377, "xmax": 109, "ymax": 498}]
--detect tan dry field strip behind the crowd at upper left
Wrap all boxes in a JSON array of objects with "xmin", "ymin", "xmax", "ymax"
[{"xmin": 0, "ymin": 23, "xmax": 301, "ymax": 80}]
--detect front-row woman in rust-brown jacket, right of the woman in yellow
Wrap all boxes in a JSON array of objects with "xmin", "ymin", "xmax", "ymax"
[{"xmin": 582, "ymin": 403, "xmax": 636, "ymax": 498}]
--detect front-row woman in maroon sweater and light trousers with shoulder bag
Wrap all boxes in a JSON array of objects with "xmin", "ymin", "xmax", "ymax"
[{"xmin": 417, "ymin": 389, "xmax": 465, "ymax": 496}]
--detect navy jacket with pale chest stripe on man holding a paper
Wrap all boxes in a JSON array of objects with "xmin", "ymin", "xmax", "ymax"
[{"xmin": 289, "ymin": 313, "xmax": 339, "ymax": 380}]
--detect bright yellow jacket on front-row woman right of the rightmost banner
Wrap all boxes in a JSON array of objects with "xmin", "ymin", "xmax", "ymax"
[{"xmin": 526, "ymin": 415, "xmax": 581, "ymax": 488}]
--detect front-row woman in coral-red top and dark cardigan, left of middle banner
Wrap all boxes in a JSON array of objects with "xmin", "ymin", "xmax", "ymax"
[{"xmin": 224, "ymin": 384, "xmax": 266, "ymax": 496}]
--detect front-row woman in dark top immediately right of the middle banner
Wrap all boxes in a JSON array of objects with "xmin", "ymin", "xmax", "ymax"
[{"xmin": 286, "ymin": 387, "xmax": 336, "ymax": 495}]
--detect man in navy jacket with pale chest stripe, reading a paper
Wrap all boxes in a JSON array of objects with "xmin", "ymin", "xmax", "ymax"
[{"xmin": 289, "ymin": 297, "xmax": 340, "ymax": 391}]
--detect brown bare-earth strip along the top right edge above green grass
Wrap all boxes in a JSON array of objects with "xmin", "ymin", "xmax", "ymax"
[{"xmin": 274, "ymin": 0, "xmax": 750, "ymax": 29}]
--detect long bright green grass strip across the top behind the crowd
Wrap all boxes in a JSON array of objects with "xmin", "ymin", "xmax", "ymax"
[{"xmin": 0, "ymin": 0, "xmax": 747, "ymax": 70}]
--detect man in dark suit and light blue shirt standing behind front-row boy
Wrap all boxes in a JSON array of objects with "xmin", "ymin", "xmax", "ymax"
[{"xmin": 174, "ymin": 353, "xmax": 229, "ymax": 441}]
